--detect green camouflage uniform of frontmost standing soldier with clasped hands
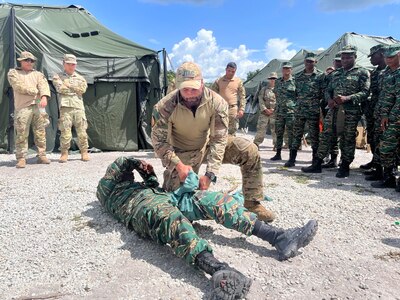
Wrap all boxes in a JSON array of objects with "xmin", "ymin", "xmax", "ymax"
[{"xmin": 318, "ymin": 66, "xmax": 370, "ymax": 164}]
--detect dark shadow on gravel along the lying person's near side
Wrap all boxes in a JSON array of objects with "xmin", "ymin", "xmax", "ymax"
[{"xmin": 82, "ymin": 201, "xmax": 220, "ymax": 300}]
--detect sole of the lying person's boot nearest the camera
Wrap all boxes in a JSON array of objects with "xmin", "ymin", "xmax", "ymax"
[{"xmin": 211, "ymin": 269, "xmax": 252, "ymax": 300}]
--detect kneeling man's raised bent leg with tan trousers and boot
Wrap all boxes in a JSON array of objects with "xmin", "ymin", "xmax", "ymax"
[{"xmin": 222, "ymin": 137, "xmax": 275, "ymax": 222}]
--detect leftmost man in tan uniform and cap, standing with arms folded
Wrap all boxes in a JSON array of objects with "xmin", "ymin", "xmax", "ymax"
[{"xmin": 7, "ymin": 51, "xmax": 50, "ymax": 168}]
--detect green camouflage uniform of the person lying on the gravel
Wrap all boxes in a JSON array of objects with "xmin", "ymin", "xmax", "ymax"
[{"xmin": 97, "ymin": 157, "xmax": 256, "ymax": 264}]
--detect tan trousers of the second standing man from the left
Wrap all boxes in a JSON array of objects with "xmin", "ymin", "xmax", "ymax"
[{"xmin": 58, "ymin": 107, "xmax": 89, "ymax": 152}]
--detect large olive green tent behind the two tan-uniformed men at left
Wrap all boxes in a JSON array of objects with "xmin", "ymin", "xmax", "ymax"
[{"xmin": 0, "ymin": 3, "xmax": 161, "ymax": 151}]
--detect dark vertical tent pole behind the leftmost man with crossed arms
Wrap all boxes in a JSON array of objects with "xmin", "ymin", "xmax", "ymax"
[{"xmin": 7, "ymin": 7, "xmax": 16, "ymax": 153}]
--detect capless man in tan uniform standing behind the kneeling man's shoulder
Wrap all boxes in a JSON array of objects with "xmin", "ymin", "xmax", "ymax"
[{"xmin": 211, "ymin": 62, "xmax": 246, "ymax": 135}]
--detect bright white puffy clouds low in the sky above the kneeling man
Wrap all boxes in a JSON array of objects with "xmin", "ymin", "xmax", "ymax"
[{"xmin": 169, "ymin": 29, "xmax": 297, "ymax": 82}]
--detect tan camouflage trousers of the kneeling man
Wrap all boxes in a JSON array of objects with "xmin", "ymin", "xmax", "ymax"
[{"xmin": 163, "ymin": 136, "xmax": 264, "ymax": 202}]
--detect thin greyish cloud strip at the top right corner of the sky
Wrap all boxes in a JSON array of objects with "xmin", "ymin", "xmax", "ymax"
[{"xmin": 317, "ymin": 0, "xmax": 400, "ymax": 11}]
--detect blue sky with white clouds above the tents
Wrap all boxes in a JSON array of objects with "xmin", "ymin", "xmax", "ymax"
[{"xmin": 2, "ymin": 0, "xmax": 400, "ymax": 80}]
